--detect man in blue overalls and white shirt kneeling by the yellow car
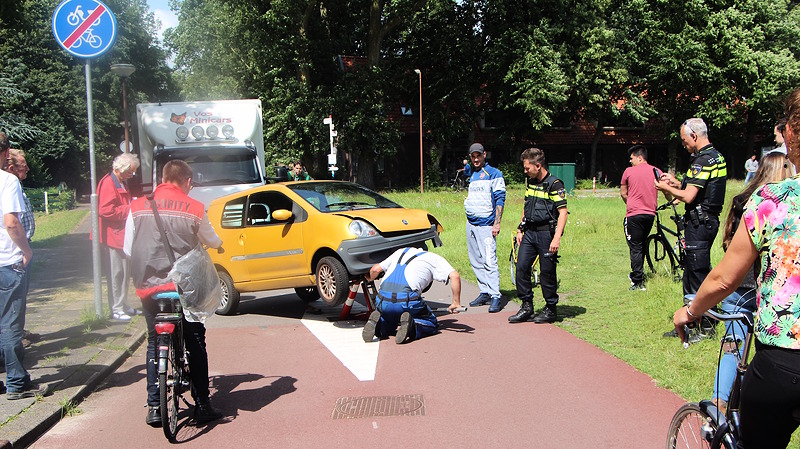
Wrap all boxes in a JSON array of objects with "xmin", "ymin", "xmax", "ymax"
[{"xmin": 361, "ymin": 248, "xmax": 461, "ymax": 344}]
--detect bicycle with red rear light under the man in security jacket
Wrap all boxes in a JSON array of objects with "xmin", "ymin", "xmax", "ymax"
[{"xmin": 152, "ymin": 292, "xmax": 192, "ymax": 443}]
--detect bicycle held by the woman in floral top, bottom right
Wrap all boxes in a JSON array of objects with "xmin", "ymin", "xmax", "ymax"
[{"xmin": 667, "ymin": 310, "xmax": 753, "ymax": 449}]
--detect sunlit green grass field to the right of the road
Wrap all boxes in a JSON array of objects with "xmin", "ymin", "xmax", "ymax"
[{"xmin": 387, "ymin": 181, "xmax": 742, "ymax": 401}]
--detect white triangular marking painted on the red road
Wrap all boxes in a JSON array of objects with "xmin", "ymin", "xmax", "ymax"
[{"xmin": 300, "ymin": 303, "xmax": 380, "ymax": 382}]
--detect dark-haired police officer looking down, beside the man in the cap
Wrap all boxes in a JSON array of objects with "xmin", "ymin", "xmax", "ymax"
[{"xmin": 508, "ymin": 148, "xmax": 567, "ymax": 323}]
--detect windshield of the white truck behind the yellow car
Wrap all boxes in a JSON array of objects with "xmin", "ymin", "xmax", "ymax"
[{"xmin": 156, "ymin": 147, "xmax": 263, "ymax": 187}]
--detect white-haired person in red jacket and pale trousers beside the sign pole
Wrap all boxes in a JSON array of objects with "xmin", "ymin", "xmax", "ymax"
[{"xmin": 97, "ymin": 153, "xmax": 139, "ymax": 321}]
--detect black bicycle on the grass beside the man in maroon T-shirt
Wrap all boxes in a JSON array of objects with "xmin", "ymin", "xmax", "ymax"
[{"xmin": 644, "ymin": 201, "xmax": 686, "ymax": 280}]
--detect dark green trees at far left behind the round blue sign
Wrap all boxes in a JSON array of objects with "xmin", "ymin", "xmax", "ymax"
[{"xmin": 0, "ymin": 0, "xmax": 175, "ymax": 191}]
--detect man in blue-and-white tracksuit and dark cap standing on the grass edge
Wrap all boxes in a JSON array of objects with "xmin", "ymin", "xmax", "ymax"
[{"xmin": 464, "ymin": 143, "xmax": 506, "ymax": 313}]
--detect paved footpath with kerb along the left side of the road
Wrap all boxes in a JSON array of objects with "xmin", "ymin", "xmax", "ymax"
[{"xmin": 0, "ymin": 205, "xmax": 144, "ymax": 448}]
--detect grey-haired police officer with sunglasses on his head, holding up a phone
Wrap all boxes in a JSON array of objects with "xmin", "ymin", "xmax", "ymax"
[{"xmin": 656, "ymin": 118, "xmax": 728, "ymax": 336}]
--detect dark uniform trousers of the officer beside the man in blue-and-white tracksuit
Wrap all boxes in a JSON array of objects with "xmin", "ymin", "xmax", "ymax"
[{"xmin": 517, "ymin": 229, "xmax": 558, "ymax": 306}]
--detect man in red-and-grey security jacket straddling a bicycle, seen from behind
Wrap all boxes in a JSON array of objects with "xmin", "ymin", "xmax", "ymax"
[{"xmin": 124, "ymin": 159, "xmax": 222, "ymax": 427}]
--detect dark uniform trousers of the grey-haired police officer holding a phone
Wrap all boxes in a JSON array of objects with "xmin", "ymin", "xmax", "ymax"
[{"xmin": 683, "ymin": 215, "xmax": 719, "ymax": 295}]
